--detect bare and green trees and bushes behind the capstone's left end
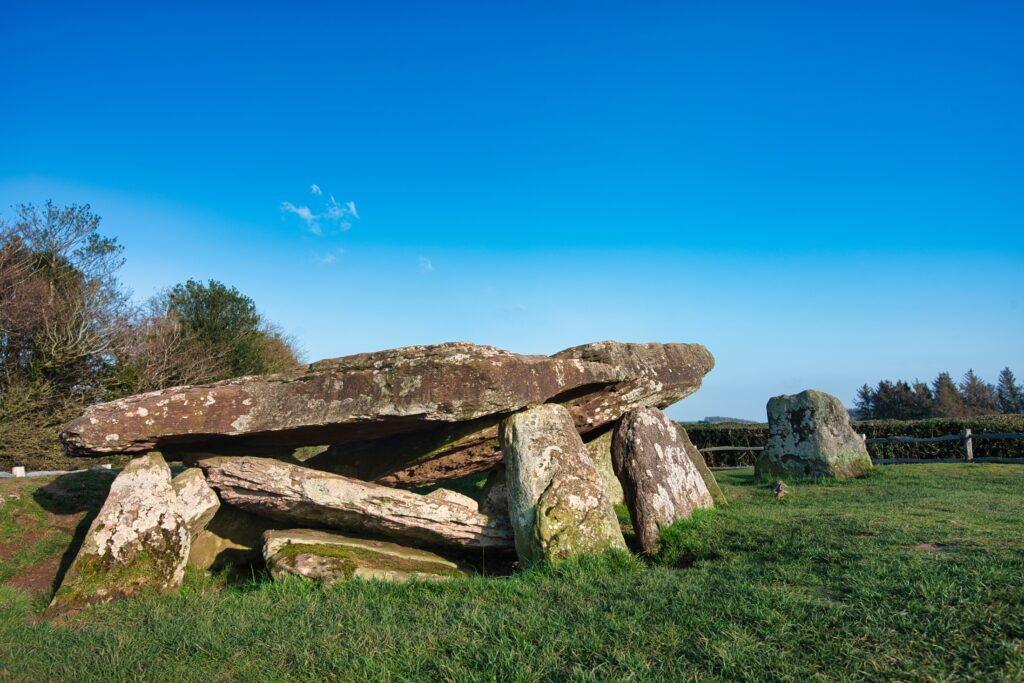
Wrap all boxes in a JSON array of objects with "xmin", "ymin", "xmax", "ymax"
[{"xmin": 0, "ymin": 203, "xmax": 298, "ymax": 467}]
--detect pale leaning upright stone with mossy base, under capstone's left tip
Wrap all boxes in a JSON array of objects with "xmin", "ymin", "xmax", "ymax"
[{"xmin": 49, "ymin": 453, "xmax": 190, "ymax": 614}]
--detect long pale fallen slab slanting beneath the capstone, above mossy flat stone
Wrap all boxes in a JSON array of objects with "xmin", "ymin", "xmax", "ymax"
[{"xmin": 200, "ymin": 457, "xmax": 513, "ymax": 549}]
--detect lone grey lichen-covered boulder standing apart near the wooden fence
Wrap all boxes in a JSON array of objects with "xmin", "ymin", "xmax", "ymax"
[{"xmin": 754, "ymin": 389, "xmax": 871, "ymax": 478}]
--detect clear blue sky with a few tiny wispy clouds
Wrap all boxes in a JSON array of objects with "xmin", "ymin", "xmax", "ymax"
[{"xmin": 0, "ymin": 0, "xmax": 1024, "ymax": 419}]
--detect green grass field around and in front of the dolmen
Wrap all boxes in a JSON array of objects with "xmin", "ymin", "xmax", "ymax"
[{"xmin": 0, "ymin": 464, "xmax": 1024, "ymax": 681}]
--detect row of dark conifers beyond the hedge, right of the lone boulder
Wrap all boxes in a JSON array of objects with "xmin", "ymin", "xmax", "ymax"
[{"xmin": 854, "ymin": 368, "xmax": 1024, "ymax": 420}]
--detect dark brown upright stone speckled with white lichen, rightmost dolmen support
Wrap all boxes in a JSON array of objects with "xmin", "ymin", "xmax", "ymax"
[{"xmin": 611, "ymin": 408, "xmax": 715, "ymax": 553}]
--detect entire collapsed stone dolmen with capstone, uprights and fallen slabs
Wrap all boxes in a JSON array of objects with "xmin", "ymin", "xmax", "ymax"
[{"xmin": 50, "ymin": 341, "xmax": 721, "ymax": 613}]
